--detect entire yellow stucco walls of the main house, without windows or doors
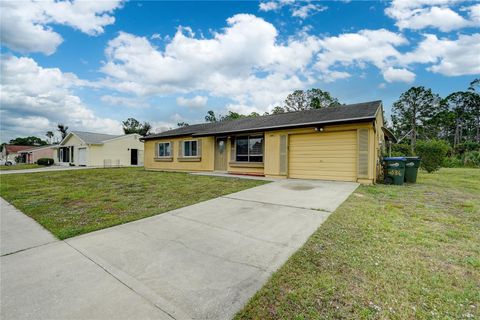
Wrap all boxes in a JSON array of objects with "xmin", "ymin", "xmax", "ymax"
[{"xmin": 145, "ymin": 120, "xmax": 383, "ymax": 183}]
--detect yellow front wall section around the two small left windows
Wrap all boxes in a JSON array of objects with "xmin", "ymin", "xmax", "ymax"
[{"xmin": 144, "ymin": 136, "xmax": 215, "ymax": 171}]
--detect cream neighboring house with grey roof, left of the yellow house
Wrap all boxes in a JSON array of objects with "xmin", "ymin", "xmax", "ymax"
[{"xmin": 56, "ymin": 131, "xmax": 143, "ymax": 167}]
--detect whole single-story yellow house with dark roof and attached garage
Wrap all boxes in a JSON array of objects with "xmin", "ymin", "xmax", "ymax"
[{"xmin": 143, "ymin": 101, "xmax": 385, "ymax": 183}]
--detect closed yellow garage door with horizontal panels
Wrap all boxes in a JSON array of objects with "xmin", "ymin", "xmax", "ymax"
[{"xmin": 288, "ymin": 131, "xmax": 357, "ymax": 181}]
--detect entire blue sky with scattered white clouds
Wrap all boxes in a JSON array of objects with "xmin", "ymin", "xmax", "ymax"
[{"xmin": 0, "ymin": 0, "xmax": 480, "ymax": 142}]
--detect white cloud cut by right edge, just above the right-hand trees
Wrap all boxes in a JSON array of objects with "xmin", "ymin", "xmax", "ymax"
[{"xmin": 399, "ymin": 33, "xmax": 480, "ymax": 76}]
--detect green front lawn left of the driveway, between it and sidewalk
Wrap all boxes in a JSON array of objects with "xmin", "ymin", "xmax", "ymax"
[{"xmin": 0, "ymin": 168, "xmax": 265, "ymax": 239}]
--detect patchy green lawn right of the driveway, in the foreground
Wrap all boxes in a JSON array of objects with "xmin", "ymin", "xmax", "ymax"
[{"xmin": 236, "ymin": 169, "xmax": 480, "ymax": 320}]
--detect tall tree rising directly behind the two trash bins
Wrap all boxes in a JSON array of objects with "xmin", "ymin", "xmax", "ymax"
[{"xmin": 392, "ymin": 87, "xmax": 440, "ymax": 153}]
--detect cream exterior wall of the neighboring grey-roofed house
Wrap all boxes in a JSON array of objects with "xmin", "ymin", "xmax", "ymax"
[{"xmin": 87, "ymin": 135, "xmax": 144, "ymax": 167}]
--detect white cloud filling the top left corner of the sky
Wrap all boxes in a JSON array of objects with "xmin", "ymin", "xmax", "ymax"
[{"xmin": 0, "ymin": 0, "xmax": 122, "ymax": 55}]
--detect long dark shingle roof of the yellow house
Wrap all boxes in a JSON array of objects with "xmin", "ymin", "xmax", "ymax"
[{"xmin": 143, "ymin": 100, "xmax": 382, "ymax": 140}]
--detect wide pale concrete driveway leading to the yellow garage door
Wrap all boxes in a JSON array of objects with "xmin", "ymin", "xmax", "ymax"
[{"xmin": 1, "ymin": 180, "xmax": 357, "ymax": 319}]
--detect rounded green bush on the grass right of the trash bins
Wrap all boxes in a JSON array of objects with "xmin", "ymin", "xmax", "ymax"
[{"xmin": 416, "ymin": 140, "xmax": 450, "ymax": 173}]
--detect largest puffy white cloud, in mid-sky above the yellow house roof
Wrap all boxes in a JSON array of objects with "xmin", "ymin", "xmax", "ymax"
[{"xmin": 102, "ymin": 14, "xmax": 319, "ymax": 112}]
